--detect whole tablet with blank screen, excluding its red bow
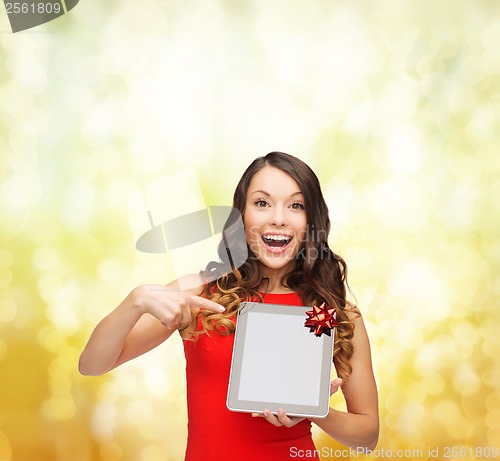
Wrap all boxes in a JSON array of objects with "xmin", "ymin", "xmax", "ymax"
[{"xmin": 227, "ymin": 302, "xmax": 334, "ymax": 418}]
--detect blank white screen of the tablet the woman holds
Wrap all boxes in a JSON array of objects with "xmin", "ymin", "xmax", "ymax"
[{"xmin": 238, "ymin": 311, "xmax": 323, "ymax": 405}]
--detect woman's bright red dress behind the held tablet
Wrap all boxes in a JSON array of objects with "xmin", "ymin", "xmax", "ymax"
[{"xmin": 184, "ymin": 293, "xmax": 319, "ymax": 461}]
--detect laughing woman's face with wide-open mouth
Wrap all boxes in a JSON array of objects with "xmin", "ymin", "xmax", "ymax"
[{"xmin": 244, "ymin": 166, "xmax": 307, "ymax": 275}]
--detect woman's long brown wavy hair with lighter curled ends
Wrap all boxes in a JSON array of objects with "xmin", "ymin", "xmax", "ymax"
[{"xmin": 192, "ymin": 152, "xmax": 359, "ymax": 380}]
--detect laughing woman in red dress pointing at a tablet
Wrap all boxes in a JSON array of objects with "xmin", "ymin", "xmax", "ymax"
[{"xmin": 80, "ymin": 152, "xmax": 379, "ymax": 460}]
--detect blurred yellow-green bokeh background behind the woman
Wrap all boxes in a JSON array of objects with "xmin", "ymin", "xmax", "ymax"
[{"xmin": 0, "ymin": 0, "xmax": 500, "ymax": 461}]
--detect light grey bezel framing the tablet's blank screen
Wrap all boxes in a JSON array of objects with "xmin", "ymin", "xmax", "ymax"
[{"xmin": 226, "ymin": 302, "xmax": 335, "ymax": 418}]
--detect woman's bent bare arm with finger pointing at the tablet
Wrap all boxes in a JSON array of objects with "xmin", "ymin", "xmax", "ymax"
[{"xmin": 78, "ymin": 274, "xmax": 224, "ymax": 375}]
